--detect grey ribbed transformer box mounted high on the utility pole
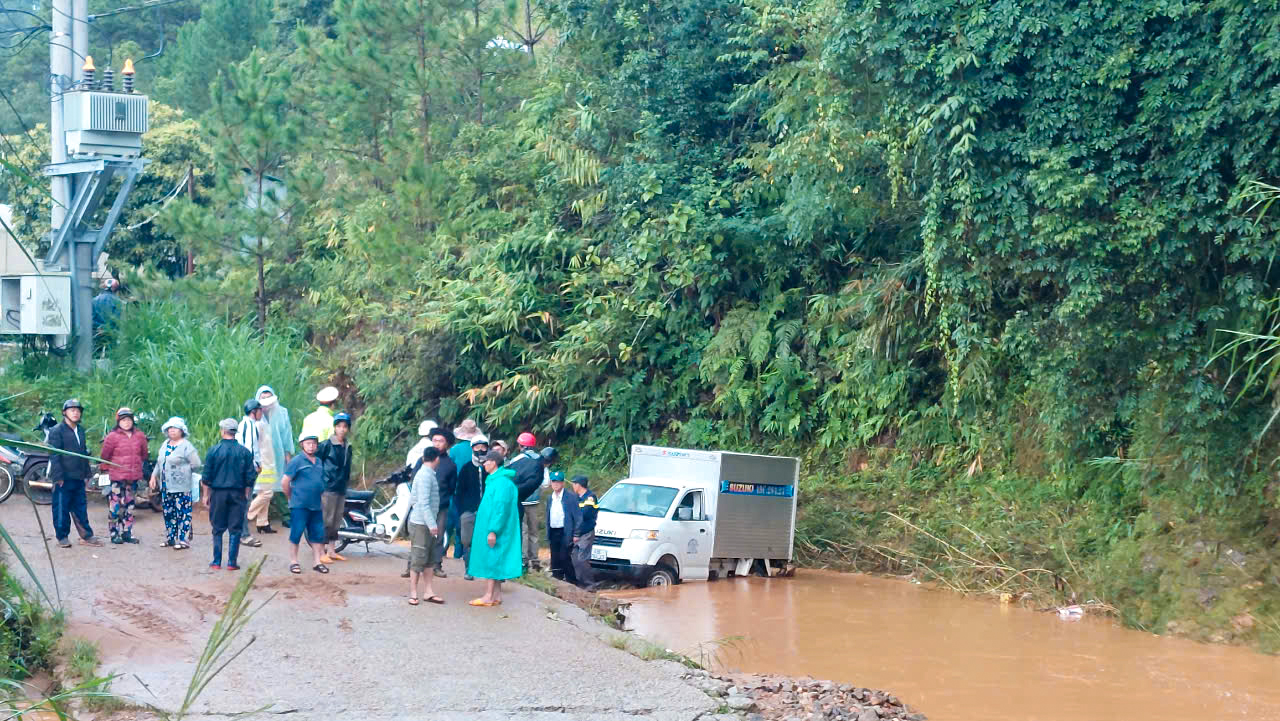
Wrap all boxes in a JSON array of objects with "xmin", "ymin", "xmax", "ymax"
[{"xmin": 63, "ymin": 90, "xmax": 147, "ymax": 158}]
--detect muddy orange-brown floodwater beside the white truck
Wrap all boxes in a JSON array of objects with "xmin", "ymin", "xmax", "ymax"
[{"xmin": 611, "ymin": 570, "xmax": 1280, "ymax": 721}]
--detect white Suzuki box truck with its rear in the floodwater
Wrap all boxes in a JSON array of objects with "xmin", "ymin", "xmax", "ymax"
[{"xmin": 591, "ymin": 446, "xmax": 800, "ymax": 585}]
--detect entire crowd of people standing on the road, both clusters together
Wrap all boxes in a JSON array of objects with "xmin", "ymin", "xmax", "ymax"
[{"xmin": 49, "ymin": 385, "xmax": 609, "ymax": 606}]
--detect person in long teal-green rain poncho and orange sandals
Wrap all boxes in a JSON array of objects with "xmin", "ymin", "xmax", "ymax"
[{"xmin": 470, "ymin": 451, "xmax": 521, "ymax": 606}]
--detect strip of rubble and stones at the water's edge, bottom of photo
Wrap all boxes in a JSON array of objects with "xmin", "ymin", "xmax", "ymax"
[{"xmin": 682, "ymin": 670, "xmax": 925, "ymax": 721}]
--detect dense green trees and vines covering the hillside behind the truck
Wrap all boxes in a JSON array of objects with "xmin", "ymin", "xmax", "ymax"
[{"xmin": 2, "ymin": 0, "xmax": 1280, "ymax": 649}]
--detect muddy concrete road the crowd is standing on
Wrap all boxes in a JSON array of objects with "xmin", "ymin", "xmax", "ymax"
[{"xmin": 0, "ymin": 494, "xmax": 714, "ymax": 721}]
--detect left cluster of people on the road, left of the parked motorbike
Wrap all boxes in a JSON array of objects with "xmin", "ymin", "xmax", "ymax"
[{"xmin": 47, "ymin": 385, "xmax": 351, "ymax": 574}]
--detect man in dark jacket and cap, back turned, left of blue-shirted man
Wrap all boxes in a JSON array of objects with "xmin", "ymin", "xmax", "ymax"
[{"xmin": 201, "ymin": 417, "xmax": 257, "ymax": 571}]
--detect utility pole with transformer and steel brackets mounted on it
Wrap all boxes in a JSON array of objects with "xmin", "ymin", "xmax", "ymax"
[{"xmin": 45, "ymin": 0, "xmax": 147, "ymax": 370}]
